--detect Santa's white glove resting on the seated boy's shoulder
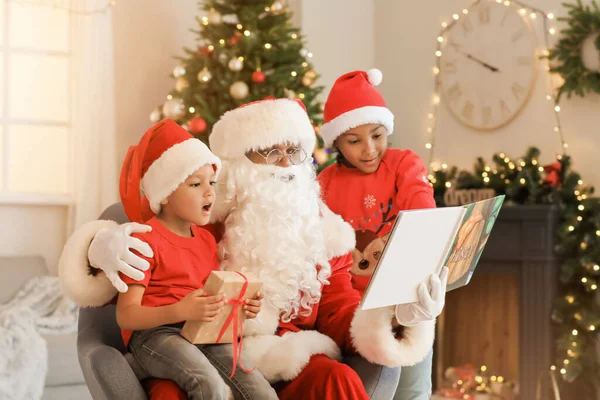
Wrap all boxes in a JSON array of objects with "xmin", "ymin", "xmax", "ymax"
[{"xmin": 88, "ymin": 222, "xmax": 154, "ymax": 293}]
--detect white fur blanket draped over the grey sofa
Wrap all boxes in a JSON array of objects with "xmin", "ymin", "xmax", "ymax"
[{"xmin": 0, "ymin": 276, "xmax": 78, "ymax": 400}]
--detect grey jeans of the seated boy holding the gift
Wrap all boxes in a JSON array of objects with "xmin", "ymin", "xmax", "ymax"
[{"xmin": 129, "ymin": 326, "xmax": 277, "ymax": 400}]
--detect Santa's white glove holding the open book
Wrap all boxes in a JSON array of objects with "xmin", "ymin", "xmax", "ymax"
[{"xmin": 396, "ymin": 267, "xmax": 448, "ymax": 326}]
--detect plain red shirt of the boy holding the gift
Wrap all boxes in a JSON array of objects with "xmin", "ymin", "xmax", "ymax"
[{"xmin": 120, "ymin": 217, "xmax": 219, "ymax": 346}]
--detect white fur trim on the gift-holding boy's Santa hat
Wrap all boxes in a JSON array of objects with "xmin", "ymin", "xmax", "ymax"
[{"xmin": 142, "ymin": 139, "xmax": 221, "ymax": 214}]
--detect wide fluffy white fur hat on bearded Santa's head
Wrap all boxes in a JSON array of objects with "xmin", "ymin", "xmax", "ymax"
[{"xmin": 209, "ymin": 99, "xmax": 317, "ymax": 160}]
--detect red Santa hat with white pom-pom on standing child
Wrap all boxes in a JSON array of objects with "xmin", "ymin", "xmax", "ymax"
[{"xmin": 319, "ymin": 69, "xmax": 394, "ymax": 147}]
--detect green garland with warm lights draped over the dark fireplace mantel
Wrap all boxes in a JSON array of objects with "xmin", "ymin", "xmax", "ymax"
[{"xmin": 429, "ymin": 148, "xmax": 600, "ymax": 394}]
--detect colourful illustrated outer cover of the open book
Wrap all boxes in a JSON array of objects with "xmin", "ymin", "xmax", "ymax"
[{"xmin": 444, "ymin": 196, "xmax": 504, "ymax": 290}]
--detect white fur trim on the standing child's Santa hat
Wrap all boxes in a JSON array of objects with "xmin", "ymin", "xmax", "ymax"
[{"xmin": 319, "ymin": 106, "xmax": 394, "ymax": 147}]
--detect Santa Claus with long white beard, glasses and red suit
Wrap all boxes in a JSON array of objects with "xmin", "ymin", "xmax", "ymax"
[{"xmin": 59, "ymin": 99, "xmax": 445, "ymax": 400}]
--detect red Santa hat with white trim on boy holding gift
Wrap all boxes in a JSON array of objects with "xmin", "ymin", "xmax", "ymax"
[{"xmin": 119, "ymin": 119, "xmax": 221, "ymax": 222}]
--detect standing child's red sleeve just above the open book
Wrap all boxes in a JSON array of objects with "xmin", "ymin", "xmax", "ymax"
[{"xmin": 396, "ymin": 151, "xmax": 435, "ymax": 210}]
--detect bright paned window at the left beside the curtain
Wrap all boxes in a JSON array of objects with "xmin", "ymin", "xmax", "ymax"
[{"xmin": 0, "ymin": 1, "xmax": 72, "ymax": 204}]
